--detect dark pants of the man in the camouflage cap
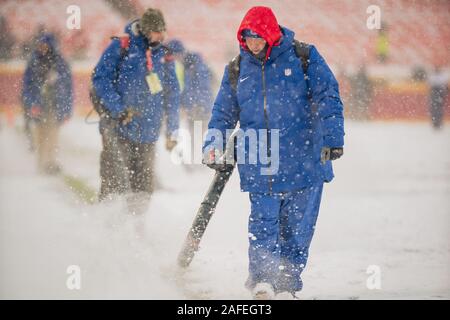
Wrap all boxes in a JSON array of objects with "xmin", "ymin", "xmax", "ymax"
[{"xmin": 99, "ymin": 119, "xmax": 155, "ymax": 201}]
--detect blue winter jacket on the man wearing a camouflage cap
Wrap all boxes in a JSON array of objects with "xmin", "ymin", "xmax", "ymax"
[{"xmin": 92, "ymin": 21, "xmax": 180, "ymax": 143}]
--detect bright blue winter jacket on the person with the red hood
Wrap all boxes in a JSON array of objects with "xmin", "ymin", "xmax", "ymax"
[{"xmin": 204, "ymin": 27, "xmax": 344, "ymax": 193}]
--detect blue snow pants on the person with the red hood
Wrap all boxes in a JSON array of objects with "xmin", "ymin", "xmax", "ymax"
[{"xmin": 246, "ymin": 183, "xmax": 323, "ymax": 292}]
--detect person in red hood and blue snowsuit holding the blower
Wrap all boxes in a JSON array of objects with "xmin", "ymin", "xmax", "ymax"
[{"xmin": 203, "ymin": 7, "xmax": 344, "ymax": 299}]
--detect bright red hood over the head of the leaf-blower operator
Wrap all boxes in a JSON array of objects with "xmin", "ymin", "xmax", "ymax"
[{"xmin": 237, "ymin": 7, "xmax": 282, "ymax": 56}]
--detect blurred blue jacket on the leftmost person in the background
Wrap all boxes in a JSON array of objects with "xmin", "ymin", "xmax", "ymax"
[{"xmin": 22, "ymin": 33, "xmax": 73, "ymax": 121}]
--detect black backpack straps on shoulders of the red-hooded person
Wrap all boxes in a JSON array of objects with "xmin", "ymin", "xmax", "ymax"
[{"xmin": 228, "ymin": 40, "xmax": 311, "ymax": 99}]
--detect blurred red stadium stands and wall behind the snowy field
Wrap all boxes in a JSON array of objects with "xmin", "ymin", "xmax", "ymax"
[{"xmin": 0, "ymin": 0, "xmax": 450, "ymax": 121}]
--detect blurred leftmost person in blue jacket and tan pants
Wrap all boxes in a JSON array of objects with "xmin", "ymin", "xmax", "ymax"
[{"xmin": 22, "ymin": 33, "xmax": 73, "ymax": 174}]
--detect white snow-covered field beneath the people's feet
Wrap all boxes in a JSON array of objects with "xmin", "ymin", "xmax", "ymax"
[{"xmin": 0, "ymin": 119, "xmax": 450, "ymax": 299}]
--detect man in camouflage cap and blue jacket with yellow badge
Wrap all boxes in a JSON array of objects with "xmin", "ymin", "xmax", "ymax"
[{"xmin": 91, "ymin": 8, "xmax": 180, "ymax": 213}]
